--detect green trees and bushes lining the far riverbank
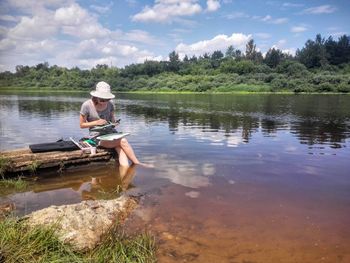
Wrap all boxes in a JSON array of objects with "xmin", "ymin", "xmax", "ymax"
[{"xmin": 0, "ymin": 35, "xmax": 350, "ymax": 93}]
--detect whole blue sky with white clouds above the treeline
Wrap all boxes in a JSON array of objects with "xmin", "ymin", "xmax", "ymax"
[{"xmin": 0, "ymin": 0, "xmax": 350, "ymax": 72}]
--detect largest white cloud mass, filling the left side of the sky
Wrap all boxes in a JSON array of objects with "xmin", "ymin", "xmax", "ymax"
[{"xmin": 0, "ymin": 0, "xmax": 161, "ymax": 70}]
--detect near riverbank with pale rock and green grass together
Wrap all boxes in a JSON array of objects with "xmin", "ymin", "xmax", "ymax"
[{"xmin": 0, "ymin": 196, "xmax": 156, "ymax": 263}]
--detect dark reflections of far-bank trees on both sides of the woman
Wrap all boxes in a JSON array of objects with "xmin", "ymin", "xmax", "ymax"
[{"xmin": 6, "ymin": 94, "xmax": 350, "ymax": 147}]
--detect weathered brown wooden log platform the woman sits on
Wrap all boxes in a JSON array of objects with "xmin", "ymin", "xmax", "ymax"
[{"xmin": 0, "ymin": 148, "xmax": 112, "ymax": 175}]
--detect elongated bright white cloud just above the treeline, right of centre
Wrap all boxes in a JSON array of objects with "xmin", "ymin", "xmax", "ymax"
[{"xmin": 175, "ymin": 33, "xmax": 251, "ymax": 57}]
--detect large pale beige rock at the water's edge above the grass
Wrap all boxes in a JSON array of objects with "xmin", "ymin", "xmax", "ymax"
[{"xmin": 26, "ymin": 196, "xmax": 137, "ymax": 251}]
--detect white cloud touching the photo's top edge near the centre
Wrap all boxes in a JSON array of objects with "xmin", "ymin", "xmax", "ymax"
[{"xmin": 132, "ymin": 0, "xmax": 202, "ymax": 22}]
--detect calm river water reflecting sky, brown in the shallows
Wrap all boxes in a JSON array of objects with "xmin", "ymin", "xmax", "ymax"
[{"xmin": 0, "ymin": 94, "xmax": 350, "ymax": 262}]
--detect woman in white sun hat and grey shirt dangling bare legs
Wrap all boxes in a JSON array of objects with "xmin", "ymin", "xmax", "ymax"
[{"xmin": 80, "ymin": 81, "xmax": 141, "ymax": 166}]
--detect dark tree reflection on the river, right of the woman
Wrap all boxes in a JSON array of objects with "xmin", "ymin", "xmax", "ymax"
[{"xmin": 125, "ymin": 95, "xmax": 350, "ymax": 147}]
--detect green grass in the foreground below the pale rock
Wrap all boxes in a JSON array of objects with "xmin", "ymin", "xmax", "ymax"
[{"xmin": 0, "ymin": 217, "xmax": 156, "ymax": 263}]
